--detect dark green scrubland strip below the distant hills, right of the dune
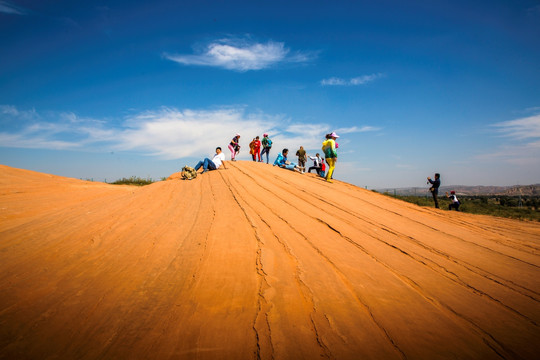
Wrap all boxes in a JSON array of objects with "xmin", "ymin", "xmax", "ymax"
[{"xmin": 383, "ymin": 192, "xmax": 540, "ymax": 221}]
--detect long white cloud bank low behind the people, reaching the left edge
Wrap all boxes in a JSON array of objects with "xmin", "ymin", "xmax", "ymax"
[{"xmin": 0, "ymin": 106, "xmax": 358, "ymax": 159}]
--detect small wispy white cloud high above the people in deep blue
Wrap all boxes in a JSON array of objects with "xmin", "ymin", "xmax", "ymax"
[{"xmin": 164, "ymin": 37, "xmax": 315, "ymax": 72}]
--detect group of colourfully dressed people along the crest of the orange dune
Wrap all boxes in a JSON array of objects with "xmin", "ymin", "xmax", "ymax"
[{"xmin": 195, "ymin": 132, "xmax": 339, "ymax": 182}]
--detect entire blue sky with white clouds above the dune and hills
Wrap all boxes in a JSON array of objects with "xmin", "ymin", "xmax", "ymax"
[{"xmin": 0, "ymin": 0, "xmax": 540, "ymax": 189}]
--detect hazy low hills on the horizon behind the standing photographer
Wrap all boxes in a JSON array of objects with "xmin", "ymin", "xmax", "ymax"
[{"xmin": 376, "ymin": 184, "xmax": 540, "ymax": 196}]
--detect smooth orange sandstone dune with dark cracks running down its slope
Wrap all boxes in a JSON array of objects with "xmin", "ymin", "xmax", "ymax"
[{"xmin": 0, "ymin": 162, "xmax": 540, "ymax": 359}]
